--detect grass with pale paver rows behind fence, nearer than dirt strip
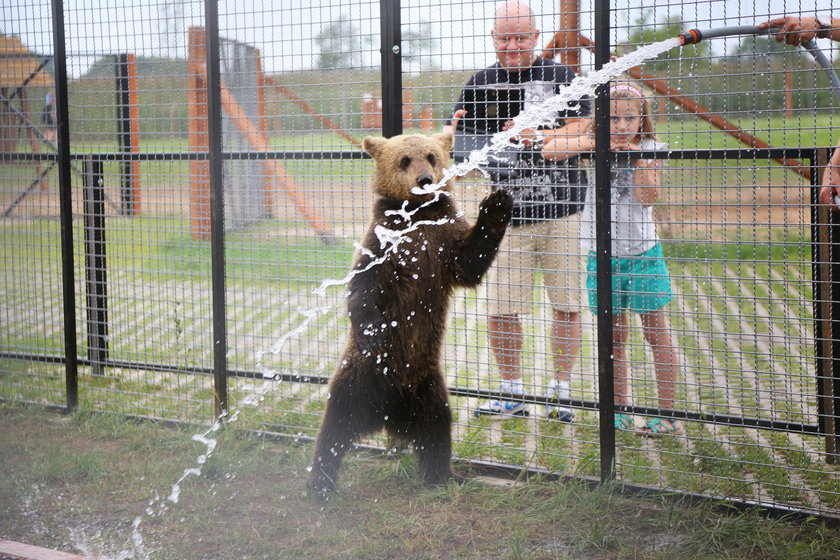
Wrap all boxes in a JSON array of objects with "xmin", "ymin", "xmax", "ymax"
[{"xmin": 0, "ymin": 211, "xmax": 840, "ymax": 513}]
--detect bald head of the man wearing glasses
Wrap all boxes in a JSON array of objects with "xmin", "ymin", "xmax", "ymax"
[{"xmin": 490, "ymin": 0, "xmax": 540, "ymax": 70}]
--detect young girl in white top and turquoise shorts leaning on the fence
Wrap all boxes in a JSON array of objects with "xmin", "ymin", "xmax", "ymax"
[{"xmin": 543, "ymin": 82, "xmax": 680, "ymax": 434}]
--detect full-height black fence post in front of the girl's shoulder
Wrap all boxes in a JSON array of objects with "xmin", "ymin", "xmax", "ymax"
[{"xmin": 595, "ymin": 0, "xmax": 615, "ymax": 482}]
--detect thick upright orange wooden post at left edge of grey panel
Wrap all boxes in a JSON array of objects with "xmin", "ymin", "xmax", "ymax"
[{"xmin": 187, "ymin": 27, "xmax": 210, "ymax": 241}]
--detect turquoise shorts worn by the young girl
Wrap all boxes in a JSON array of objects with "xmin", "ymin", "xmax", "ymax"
[{"xmin": 586, "ymin": 243, "xmax": 674, "ymax": 315}]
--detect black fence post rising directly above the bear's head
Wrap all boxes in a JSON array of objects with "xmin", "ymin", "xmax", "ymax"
[{"xmin": 379, "ymin": 0, "xmax": 403, "ymax": 138}]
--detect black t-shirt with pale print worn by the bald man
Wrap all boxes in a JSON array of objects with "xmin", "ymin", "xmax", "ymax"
[{"xmin": 453, "ymin": 57, "xmax": 591, "ymax": 225}]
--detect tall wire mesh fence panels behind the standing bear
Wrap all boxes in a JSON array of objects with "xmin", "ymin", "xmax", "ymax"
[{"xmin": 0, "ymin": 0, "xmax": 840, "ymax": 516}]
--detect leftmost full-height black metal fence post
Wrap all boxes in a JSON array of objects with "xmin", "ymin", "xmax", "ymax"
[{"xmin": 52, "ymin": 0, "xmax": 79, "ymax": 410}]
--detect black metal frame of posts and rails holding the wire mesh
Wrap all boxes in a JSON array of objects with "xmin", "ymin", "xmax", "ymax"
[{"xmin": 0, "ymin": 0, "xmax": 840, "ymax": 524}]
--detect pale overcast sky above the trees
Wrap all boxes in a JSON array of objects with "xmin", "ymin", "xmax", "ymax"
[{"xmin": 0, "ymin": 0, "xmax": 832, "ymax": 77}]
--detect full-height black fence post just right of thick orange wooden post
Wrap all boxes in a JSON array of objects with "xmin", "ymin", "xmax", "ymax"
[{"xmin": 204, "ymin": 0, "xmax": 228, "ymax": 418}]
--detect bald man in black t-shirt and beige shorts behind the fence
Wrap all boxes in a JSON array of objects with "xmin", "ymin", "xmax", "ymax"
[{"xmin": 444, "ymin": 1, "xmax": 591, "ymax": 422}]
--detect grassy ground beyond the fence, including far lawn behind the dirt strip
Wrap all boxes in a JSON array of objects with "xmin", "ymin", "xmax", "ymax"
[{"xmin": 0, "ymin": 97, "xmax": 840, "ymax": 524}]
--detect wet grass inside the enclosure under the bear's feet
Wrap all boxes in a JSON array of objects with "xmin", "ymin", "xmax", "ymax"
[{"xmin": 0, "ymin": 405, "xmax": 840, "ymax": 560}]
